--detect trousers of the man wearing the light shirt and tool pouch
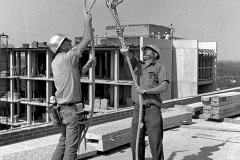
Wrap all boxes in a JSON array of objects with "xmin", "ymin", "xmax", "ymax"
[{"xmin": 52, "ymin": 105, "xmax": 84, "ymax": 160}]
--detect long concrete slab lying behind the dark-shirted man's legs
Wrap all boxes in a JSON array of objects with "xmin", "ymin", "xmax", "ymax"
[{"xmin": 86, "ymin": 108, "xmax": 192, "ymax": 152}]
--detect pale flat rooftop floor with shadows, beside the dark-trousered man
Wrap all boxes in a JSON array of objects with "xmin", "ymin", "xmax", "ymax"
[{"xmin": 84, "ymin": 119, "xmax": 240, "ymax": 160}]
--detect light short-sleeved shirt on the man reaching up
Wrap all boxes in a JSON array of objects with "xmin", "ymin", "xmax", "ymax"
[{"xmin": 52, "ymin": 47, "xmax": 82, "ymax": 104}]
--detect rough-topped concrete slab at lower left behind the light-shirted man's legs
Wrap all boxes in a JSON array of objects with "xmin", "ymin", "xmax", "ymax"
[{"xmin": 0, "ymin": 134, "xmax": 97, "ymax": 160}]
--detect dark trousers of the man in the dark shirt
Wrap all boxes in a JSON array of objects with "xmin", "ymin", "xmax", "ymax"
[{"xmin": 131, "ymin": 105, "xmax": 164, "ymax": 160}]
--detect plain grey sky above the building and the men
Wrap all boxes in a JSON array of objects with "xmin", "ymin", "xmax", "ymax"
[{"xmin": 0, "ymin": 0, "xmax": 240, "ymax": 61}]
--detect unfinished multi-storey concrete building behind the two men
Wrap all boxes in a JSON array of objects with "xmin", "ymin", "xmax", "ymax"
[{"xmin": 0, "ymin": 24, "xmax": 232, "ymax": 160}]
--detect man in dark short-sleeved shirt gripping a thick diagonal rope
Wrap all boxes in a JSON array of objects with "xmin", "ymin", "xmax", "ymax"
[{"xmin": 121, "ymin": 44, "xmax": 169, "ymax": 160}]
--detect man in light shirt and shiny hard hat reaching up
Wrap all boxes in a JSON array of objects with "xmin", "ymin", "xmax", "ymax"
[{"xmin": 48, "ymin": 14, "xmax": 96, "ymax": 160}]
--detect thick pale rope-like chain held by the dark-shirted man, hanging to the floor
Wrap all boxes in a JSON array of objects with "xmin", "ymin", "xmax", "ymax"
[{"xmin": 106, "ymin": 0, "xmax": 143, "ymax": 160}]
